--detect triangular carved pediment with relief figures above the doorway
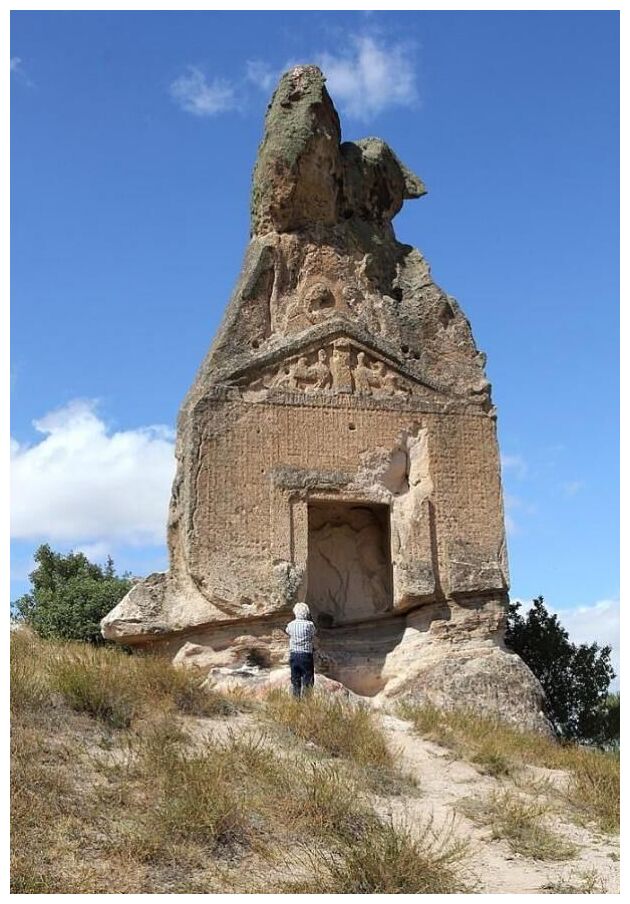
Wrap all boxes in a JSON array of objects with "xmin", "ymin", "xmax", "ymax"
[{"xmin": 235, "ymin": 336, "xmax": 450, "ymax": 400}]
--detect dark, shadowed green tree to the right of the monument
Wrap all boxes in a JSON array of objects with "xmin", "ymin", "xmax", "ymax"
[{"xmin": 505, "ymin": 596, "xmax": 618, "ymax": 745}]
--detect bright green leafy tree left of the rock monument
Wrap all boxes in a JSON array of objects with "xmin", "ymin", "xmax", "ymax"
[{"xmin": 13, "ymin": 544, "xmax": 131, "ymax": 644}]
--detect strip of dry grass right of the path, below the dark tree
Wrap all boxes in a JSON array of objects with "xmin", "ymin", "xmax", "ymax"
[{"xmin": 399, "ymin": 703, "xmax": 619, "ymax": 832}]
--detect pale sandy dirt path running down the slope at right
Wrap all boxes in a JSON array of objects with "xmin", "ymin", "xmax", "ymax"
[{"xmin": 378, "ymin": 715, "xmax": 619, "ymax": 894}]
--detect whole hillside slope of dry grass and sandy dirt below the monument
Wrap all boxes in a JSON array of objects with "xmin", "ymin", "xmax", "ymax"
[{"xmin": 11, "ymin": 631, "xmax": 619, "ymax": 894}]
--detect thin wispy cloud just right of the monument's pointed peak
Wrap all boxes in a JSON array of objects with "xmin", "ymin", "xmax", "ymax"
[{"xmin": 313, "ymin": 35, "xmax": 418, "ymax": 122}]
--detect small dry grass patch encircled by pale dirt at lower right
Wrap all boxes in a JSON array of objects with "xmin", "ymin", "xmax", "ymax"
[{"xmin": 460, "ymin": 790, "xmax": 577, "ymax": 861}]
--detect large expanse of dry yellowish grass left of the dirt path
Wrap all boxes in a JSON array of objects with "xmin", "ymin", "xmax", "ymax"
[{"xmin": 11, "ymin": 632, "xmax": 454, "ymax": 894}]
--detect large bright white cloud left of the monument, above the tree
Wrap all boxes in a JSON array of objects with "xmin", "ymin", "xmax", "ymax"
[{"xmin": 11, "ymin": 400, "xmax": 175, "ymax": 554}]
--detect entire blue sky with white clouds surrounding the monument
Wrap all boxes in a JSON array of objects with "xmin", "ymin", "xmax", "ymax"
[{"xmin": 11, "ymin": 12, "xmax": 619, "ymax": 680}]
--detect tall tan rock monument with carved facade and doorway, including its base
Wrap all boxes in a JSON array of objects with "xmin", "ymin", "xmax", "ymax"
[{"xmin": 102, "ymin": 66, "xmax": 546, "ymax": 728}]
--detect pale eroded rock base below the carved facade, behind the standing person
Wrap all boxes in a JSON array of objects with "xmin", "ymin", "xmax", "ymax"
[{"xmin": 108, "ymin": 575, "xmax": 551, "ymax": 733}]
